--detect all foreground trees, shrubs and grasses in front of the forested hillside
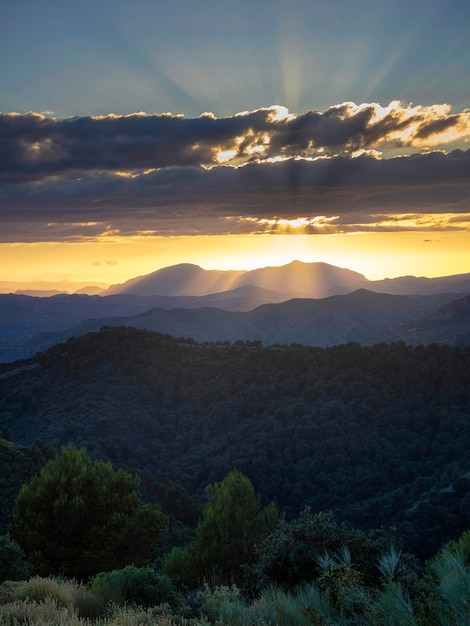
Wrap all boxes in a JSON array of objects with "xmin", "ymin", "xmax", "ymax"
[{"xmin": 0, "ymin": 446, "xmax": 470, "ymax": 626}]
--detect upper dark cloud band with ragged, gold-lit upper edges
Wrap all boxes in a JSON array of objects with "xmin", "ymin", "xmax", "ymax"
[{"xmin": 0, "ymin": 102, "xmax": 470, "ymax": 184}]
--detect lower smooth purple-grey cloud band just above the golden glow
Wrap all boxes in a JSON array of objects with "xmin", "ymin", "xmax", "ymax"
[{"xmin": 0, "ymin": 150, "xmax": 470, "ymax": 240}]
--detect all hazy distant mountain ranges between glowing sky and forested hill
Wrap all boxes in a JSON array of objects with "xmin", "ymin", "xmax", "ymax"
[{"xmin": 0, "ymin": 261, "xmax": 470, "ymax": 361}]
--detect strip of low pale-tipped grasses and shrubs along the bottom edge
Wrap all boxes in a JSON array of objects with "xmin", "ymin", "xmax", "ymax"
[{"xmin": 0, "ymin": 546, "xmax": 470, "ymax": 626}]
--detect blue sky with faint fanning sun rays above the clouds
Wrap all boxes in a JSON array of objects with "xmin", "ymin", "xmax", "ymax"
[{"xmin": 0, "ymin": 0, "xmax": 470, "ymax": 116}]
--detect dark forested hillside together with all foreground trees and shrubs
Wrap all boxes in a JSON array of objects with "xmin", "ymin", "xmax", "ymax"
[{"xmin": 0, "ymin": 328, "xmax": 470, "ymax": 626}]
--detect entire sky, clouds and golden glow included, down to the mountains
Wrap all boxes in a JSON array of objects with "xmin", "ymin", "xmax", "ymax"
[{"xmin": 0, "ymin": 0, "xmax": 470, "ymax": 285}]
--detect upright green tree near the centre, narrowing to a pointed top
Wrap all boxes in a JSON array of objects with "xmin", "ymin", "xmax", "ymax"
[{"xmin": 164, "ymin": 471, "xmax": 278, "ymax": 585}]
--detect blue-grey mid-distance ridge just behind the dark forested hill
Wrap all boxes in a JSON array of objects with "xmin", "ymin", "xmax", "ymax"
[{"xmin": 15, "ymin": 289, "xmax": 453, "ymax": 356}]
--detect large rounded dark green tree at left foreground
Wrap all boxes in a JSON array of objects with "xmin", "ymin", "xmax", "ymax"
[{"xmin": 10, "ymin": 445, "xmax": 168, "ymax": 579}]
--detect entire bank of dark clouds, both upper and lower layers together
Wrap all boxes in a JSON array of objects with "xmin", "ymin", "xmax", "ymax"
[{"xmin": 0, "ymin": 102, "xmax": 470, "ymax": 241}]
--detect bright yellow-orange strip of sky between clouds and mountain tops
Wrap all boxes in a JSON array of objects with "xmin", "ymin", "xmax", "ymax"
[{"xmin": 0, "ymin": 231, "xmax": 470, "ymax": 288}]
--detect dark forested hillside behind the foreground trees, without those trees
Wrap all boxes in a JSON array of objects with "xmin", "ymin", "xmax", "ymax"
[{"xmin": 0, "ymin": 328, "xmax": 470, "ymax": 555}]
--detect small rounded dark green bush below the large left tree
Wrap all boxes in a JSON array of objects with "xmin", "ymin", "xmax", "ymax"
[{"xmin": 89, "ymin": 565, "xmax": 180, "ymax": 607}]
